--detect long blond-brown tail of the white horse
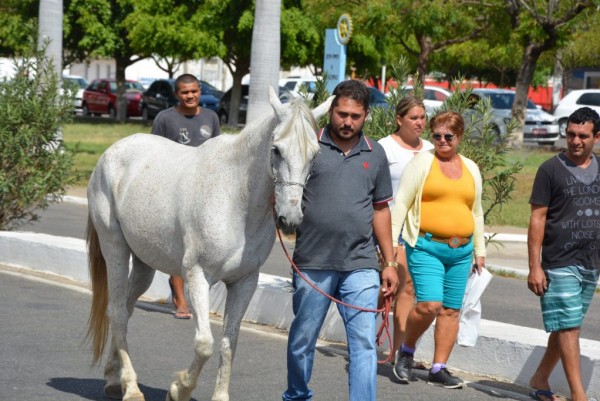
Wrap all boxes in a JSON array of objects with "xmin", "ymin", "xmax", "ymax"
[{"xmin": 86, "ymin": 215, "xmax": 109, "ymax": 364}]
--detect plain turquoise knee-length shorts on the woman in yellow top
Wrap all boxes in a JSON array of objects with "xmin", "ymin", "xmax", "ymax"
[{"xmin": 406, "ymin": 231, "xmax": 473, "ymax": 309}]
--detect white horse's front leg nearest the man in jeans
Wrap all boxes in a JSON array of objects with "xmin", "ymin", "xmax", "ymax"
[{"xmin": 212, "ymin": 270, "xmax": 258, "ymax": 401}]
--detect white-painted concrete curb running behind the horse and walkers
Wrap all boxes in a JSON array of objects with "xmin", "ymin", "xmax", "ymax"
[{"xmin": 0, "ymin": 231, "xmax": 600, "ymax": 397}]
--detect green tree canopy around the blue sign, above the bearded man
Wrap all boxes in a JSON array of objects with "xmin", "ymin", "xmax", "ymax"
[{"xmin": 305, "ymin": 0, "xmax": 490, "ymax": 77}]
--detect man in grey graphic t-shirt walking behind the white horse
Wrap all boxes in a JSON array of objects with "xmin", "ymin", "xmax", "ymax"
[{"xmin": 152, "ymin": 74, "xmax": 221, "ymax": 319}]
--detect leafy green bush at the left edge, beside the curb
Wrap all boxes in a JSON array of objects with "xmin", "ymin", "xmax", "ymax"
[{"xmin": 0, "ymin": 45, "xmax": 76, "ymax": 230}]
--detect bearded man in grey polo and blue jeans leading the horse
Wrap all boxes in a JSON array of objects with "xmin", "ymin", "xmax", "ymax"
[{"xmin": 282, "ymin": 80, "xmax": 398, "ymax": 401}]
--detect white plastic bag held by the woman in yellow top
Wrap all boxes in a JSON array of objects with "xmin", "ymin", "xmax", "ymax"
[{"xmin": 456, "ymin": 268, "xmax": 493, "ymax": 347}]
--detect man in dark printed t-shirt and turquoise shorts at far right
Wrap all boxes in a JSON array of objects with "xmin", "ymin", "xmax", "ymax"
[{"xmin": 527, "ymin": 107, "xmax": 600, "ymax": 401}]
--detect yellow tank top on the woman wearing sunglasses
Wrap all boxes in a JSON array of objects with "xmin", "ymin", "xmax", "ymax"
[{"xmin": 420, "ymin": 159, "xmax": 475, "ymax": 238}]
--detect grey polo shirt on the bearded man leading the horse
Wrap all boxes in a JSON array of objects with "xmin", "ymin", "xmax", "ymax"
[{"xmin": 294, "ymin": 126, "xmax": 393, "ymax": 271}]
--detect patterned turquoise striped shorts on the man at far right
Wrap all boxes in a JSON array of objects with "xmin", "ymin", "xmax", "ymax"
[{"xmin": 540, "ymin": 266, "xmax": 600, "ymax": 333}]
